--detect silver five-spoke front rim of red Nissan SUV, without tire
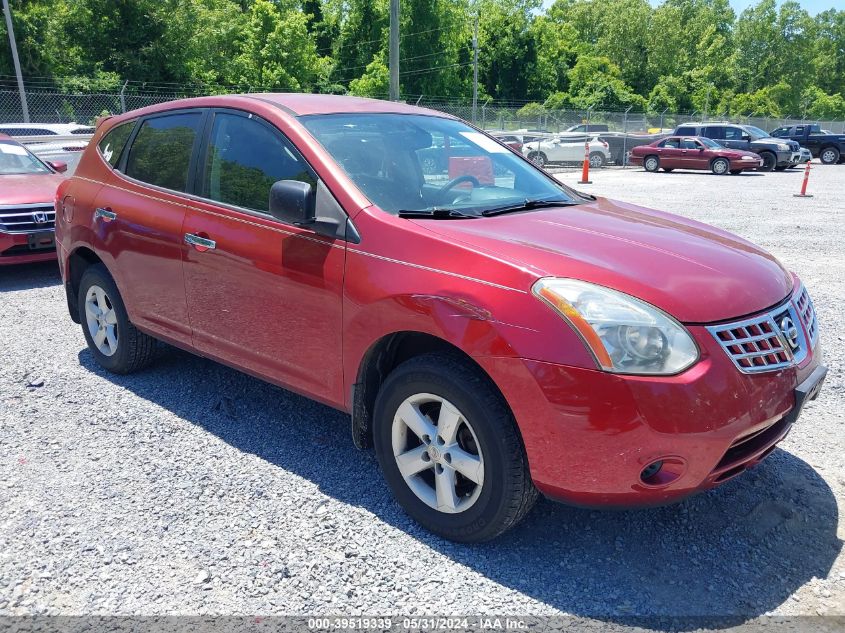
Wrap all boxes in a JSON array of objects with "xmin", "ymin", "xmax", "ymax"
[{"xmin": 392, "ymin": 393, "xmax": 484, "ymax": 514}]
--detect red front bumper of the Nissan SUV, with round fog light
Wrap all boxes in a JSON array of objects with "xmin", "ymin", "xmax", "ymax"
[{"xmin": 479, "ymin": 292, "xmax": 826, "ymax": 508}]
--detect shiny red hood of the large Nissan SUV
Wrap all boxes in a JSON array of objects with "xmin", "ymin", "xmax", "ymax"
[{"xmin": 418, "ymin": 198, "xmax": 793, "ymax": 323}]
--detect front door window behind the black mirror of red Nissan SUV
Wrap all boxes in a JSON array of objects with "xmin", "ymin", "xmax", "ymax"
[{"xmin": 202, "ymin": 114, "xmax": 317, "ymax": 212}]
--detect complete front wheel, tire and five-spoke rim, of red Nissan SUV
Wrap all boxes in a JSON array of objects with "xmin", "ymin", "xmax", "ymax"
[{"xmin": 373, "ymin": 354, "xmax": 537, "ymax": 543}]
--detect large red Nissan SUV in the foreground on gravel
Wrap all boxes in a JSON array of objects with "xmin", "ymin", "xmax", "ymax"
[{"xmin": 56, "ymin": 94, "xmax": 826, "ymax": 541}]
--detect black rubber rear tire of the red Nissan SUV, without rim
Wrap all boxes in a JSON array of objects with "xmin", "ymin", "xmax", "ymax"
[{"xmin": 77, "ymin": 264, "xmax": 156, "ymax": 374}]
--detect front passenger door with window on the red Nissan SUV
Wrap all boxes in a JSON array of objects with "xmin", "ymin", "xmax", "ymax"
[{"xmin": 184, "ymin": 111, "xmax": 346, "ymax": 402}]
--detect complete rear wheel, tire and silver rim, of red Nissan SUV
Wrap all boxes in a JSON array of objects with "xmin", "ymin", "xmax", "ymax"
[{"xmin": 78, "ymin": 264, "xmax": 156, "ymax": 374}]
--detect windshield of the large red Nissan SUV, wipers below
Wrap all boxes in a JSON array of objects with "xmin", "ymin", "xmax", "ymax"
[{"xmin": 300, "ymin": 113, "xmax": 582, "ymax": 215}]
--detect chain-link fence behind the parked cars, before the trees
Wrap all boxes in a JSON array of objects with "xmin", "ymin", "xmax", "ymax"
[{"xmin": 0, "ymin": 88, "xmax": 845, "ymax": 133}]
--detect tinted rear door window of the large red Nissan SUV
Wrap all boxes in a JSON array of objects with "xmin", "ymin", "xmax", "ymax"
[{"xmin": 126, "ymin": 112, "xmax": 202, "ymax": 191}]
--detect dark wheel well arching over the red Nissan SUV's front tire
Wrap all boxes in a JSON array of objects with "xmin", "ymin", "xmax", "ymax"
[{"xmin": 352, "ymin": 332, "xmax": 507, "ymax": 448}]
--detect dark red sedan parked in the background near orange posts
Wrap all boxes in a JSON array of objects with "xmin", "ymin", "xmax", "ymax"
[{"xmin": 630, "ymin": 136, "xmax": 763, "ymax": 176}]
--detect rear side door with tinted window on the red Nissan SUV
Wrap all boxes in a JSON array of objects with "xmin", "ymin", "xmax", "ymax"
[{"xmin": 93, "ymin": 109, "xmax": 206, "ymax": 343}]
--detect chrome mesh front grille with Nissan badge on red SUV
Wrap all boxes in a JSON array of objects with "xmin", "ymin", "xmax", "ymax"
[{"xmin": 707, "ymin": 286, "xmax": 818, "ymax": 374}]
